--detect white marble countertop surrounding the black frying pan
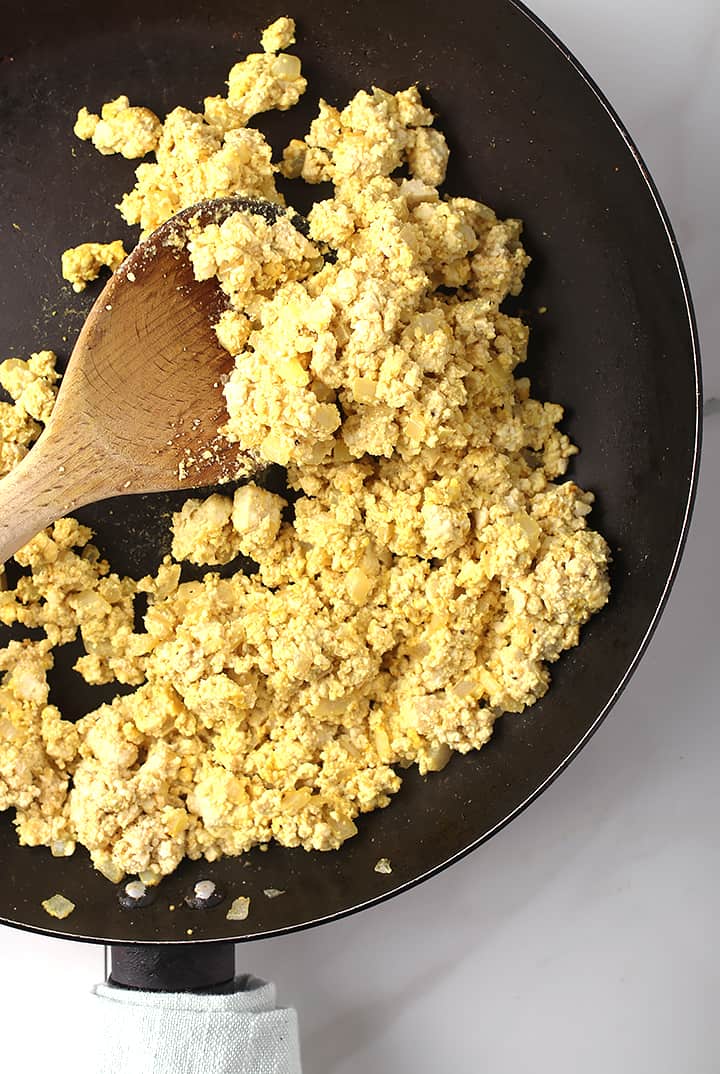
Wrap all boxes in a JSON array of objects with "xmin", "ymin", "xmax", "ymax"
[{"xmin": 0, "ymin": 0, "xmax": 720, "ymax": 1074}]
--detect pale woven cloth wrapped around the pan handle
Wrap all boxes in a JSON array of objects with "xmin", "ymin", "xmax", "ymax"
[{"xmin": 93, "ymin": 976, "xmax": 301, "ymax": 1074}]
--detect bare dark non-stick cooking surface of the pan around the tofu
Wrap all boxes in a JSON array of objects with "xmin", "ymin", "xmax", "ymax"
[{"xmin": 0, "ymin": 0, "xmax": 700, "ymax": 942}]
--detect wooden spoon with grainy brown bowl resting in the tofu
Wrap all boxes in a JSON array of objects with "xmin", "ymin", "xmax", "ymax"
[{"xmin": 0, "ymin": 198, "xmax": 283, "ymax": 565}]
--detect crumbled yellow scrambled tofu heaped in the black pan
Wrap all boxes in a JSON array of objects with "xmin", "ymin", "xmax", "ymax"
[{"xmin": 0, "ymin": 18, "xmax": 609, "ymax": 883}]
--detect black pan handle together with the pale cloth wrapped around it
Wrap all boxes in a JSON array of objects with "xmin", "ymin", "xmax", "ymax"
[{"xmin": 92, "ymin": 944, "xmax": 302, "ymax": 1074}]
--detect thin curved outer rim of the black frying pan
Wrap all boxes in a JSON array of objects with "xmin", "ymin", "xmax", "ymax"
[{"xmin": 0, "ymin": 0, "xmax": 703, "ymax": 946}]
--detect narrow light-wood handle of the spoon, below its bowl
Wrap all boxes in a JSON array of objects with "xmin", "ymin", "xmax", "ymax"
[{"xmin": 0, "ymin": 429, "xmax": 114, "ymax": 565}]
